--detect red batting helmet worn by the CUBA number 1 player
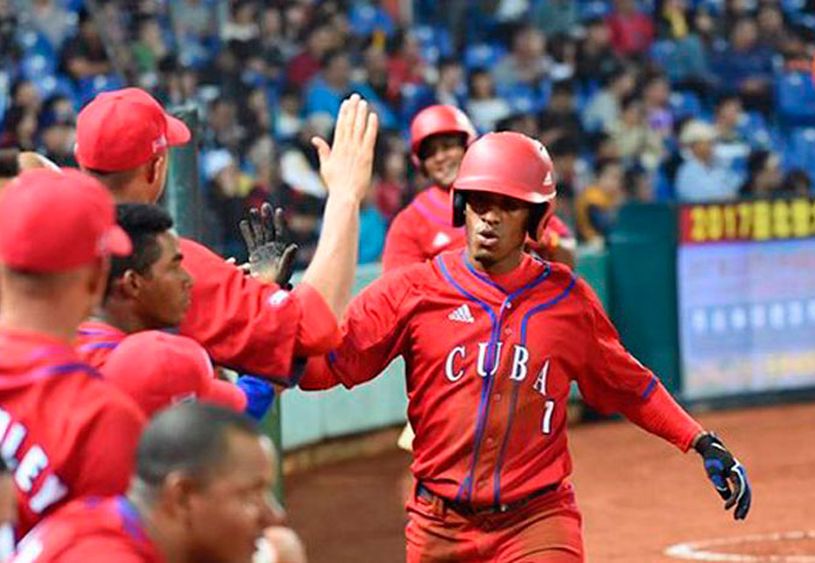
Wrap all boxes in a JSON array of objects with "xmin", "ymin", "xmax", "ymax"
[{"xmin": 452, "ymin": 132, "xmax": 555, "ymax": 239}]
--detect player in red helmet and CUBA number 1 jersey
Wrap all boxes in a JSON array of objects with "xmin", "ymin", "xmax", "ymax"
[{"xmin": 300, "ymin": 133, "xmax": 751, "ymax": 562}]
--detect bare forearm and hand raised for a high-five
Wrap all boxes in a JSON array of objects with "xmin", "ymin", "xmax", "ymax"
[{"xmin": 303, "ymin": 94, "xmax": 379, "ymax": 318}]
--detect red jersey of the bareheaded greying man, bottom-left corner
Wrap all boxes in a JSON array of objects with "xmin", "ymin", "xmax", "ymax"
[{"xmin": 9, "ymin": 497, "xmax": 165, "ymax": 563}]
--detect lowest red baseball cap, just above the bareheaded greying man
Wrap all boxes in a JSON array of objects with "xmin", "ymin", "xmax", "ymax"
[{"xmin": 102, "ymin": 330, "xmax": 246, "ymax": 416}]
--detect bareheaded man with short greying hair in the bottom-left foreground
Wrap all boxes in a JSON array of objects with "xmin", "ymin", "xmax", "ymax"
[{"xmin": 12, "ymin": 403, "xmax": 287, "ymax": 563}]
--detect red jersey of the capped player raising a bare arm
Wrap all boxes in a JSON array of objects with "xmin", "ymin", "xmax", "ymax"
[{"xmin": 179, "ymin": 238, "xmax": 340, "ymax": 385}]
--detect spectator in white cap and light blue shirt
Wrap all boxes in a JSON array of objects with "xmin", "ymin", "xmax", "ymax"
[{"xmin": 675, "ymin": 120, "xmax": 740, "ymax": 203}]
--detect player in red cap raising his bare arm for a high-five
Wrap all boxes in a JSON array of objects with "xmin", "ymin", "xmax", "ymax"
[{"xmin": 75, "ymin": 88, "xmax": 378, "ymax": 385}]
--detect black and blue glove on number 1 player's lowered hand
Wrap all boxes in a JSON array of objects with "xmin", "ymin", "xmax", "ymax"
[{"xmin": 694, "ymin": 432, "xmax": 753, "ymax": 520}]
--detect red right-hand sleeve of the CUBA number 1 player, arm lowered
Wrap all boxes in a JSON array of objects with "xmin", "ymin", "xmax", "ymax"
[{"xmin": 578, "ymin": 280, "xmax": 701, "ymax": 451}]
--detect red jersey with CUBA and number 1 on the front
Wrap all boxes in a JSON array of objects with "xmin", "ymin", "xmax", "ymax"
[{"xmin": 300, "ymin": 251, "xmax": 701, "ymax": 506}]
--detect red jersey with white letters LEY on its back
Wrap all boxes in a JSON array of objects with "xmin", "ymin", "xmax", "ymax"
[{"xmin": 0, "ymin": 331, "xmax": 145, "ymax": 537}]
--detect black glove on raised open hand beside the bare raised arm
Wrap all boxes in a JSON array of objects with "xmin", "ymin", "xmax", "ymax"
[{"xmin": 240, "ymin": 203, "xmax": 297, "ymax": 289}]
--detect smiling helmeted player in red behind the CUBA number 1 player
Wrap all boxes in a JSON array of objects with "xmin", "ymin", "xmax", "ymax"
[{"xmin": 382, "ymin": 105, "xmax": 574, "ymax": 272}]
